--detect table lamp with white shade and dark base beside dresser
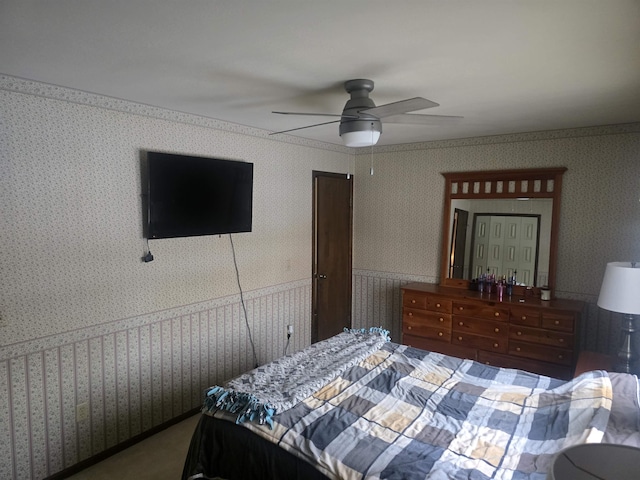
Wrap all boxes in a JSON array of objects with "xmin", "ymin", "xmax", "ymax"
[{"xmin": 598, "ymin": 262, "xmax": 640, "ymax": 373}]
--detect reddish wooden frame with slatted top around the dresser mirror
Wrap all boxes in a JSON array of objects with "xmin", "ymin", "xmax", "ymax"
[{"xmin": 440, "ymin": 167, "xmax": 567, "ymax": 292}]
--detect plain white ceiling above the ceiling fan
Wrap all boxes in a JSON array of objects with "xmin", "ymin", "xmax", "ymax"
[{"xmin": 0, "ymin": 0, "xmax": 640, "ymax": 145}]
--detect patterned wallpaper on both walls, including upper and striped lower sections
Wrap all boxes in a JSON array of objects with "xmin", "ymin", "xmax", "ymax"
[{"xmin": 0, "ymin": 76, "xmax": 640, "ymax": 478}]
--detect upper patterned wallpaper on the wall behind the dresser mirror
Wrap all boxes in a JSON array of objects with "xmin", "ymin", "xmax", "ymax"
[{"xmin": 354, "ymin": 125, "xmax": 640, "ymax": 295}]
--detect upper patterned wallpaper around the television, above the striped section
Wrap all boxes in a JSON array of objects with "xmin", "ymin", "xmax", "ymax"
[{"xmin": 0, "ymin": 86, "xmax": 346, "ymax": 345}]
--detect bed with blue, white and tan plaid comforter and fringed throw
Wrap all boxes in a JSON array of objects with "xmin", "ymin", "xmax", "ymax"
[{"xmin": 183, "ymin": 329, "xmax": 640, "ymax": 480}]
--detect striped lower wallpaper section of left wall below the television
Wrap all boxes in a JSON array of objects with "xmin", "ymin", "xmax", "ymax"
[{"xmin": 0, "ymin": 280, "xmax": 311, "ymax": 480}]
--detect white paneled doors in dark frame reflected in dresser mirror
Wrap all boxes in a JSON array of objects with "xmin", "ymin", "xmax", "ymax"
[{"xmin": 470, "ymin": 213, "xmax": 540, "ymax": 285}]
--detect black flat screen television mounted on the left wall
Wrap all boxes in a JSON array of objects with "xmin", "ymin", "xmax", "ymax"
[{"xmin": 146, "ymin": 152, "xmax": 253, "ymax": 238}]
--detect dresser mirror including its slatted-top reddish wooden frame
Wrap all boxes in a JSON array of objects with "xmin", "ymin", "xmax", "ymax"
[{"xmin": 440, "ymin": 168, "xmax": 566, "ymax": 290}]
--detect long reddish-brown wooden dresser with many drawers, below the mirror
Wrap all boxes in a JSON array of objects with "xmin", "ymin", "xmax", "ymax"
[{"xmin": 402, "ymin": 283, "xmax": 585, "ymax": 379}]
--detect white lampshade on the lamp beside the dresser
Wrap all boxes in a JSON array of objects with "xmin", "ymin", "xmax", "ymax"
[{"xmin": 598, "ymin": 262, "xmax": 640, "ymax": 315}]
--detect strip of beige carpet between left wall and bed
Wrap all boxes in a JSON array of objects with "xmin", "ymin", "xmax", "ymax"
[{"xmin": 69, "ymin": 413, "xmax": 200, "ymax": 480}]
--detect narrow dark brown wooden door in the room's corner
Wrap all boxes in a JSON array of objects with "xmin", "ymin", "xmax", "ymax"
[{"xmin": 311, "ymin": 172, "xmax": 353, "ymax": 342}]
